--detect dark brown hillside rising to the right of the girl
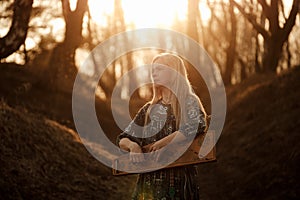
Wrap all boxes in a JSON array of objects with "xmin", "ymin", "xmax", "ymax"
[{"xmin": 200, "ymin": 68, "xmax": 300, "ymax": 199}]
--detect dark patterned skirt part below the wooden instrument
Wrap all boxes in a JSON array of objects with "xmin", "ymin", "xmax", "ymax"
[{"xmin": 132, "ymin": 166, "xmax": 200, "ymax": 200}]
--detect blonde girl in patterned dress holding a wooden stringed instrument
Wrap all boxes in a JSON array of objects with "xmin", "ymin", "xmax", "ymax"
[{"xmin": 117, "ymin": 53, "xmax": 207, "ymax": 200}]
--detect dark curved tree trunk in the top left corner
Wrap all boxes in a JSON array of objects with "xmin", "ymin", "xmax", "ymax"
[{"xmin": 0, "ymin": 0, "xmax": 33, "ymax": 59}]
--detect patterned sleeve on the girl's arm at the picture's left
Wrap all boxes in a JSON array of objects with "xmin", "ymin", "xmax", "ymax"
[{"xmin": 116, "ymin": 103, "xmax": 150, "ymax": 145}]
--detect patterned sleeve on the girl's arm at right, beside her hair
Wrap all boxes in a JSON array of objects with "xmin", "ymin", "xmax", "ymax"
[{"xmin": 179, "ymin": 98, "xmax": 206, "ymax": 137}]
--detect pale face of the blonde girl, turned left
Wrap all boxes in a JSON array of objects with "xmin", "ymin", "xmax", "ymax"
[{"xmin": 152, "ymin": 62, "xmax": 176, "ymax": 88}]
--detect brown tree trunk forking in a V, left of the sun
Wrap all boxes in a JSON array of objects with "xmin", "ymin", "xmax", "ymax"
[{"xmin": 49, "ymin": 0, "xmax": 88, "ymax": 90}]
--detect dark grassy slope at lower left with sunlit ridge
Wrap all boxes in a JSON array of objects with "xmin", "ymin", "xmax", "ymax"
[{"xmin": 0, "ymin": 101, "xmax": 133, "ymax": 199}]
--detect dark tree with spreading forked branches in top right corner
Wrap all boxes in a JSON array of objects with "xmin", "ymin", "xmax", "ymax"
[{"xmin": 233, "ymin": 0, "xmax": 300, "ymax": 72}]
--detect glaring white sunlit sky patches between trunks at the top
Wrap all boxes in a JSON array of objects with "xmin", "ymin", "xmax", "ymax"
[{"xmin": 89, "ymin": 0, "xmax": 210, "ymax": 28}]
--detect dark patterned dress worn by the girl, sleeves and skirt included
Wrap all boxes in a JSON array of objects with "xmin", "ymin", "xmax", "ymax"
[{"xmin": 117, "ymin": 97, "xmax": 206, "ymax": 200}]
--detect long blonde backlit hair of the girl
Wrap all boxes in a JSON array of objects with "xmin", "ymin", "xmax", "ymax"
[{"xmin": 145, "ymin": 53, "xmax": 206, "ymax": 129}]
